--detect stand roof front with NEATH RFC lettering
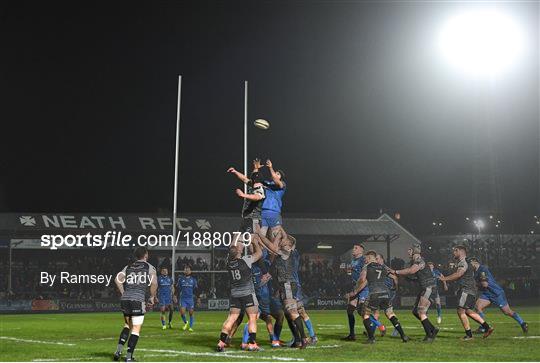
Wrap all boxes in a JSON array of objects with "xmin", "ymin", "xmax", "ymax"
[{"xmin": 0, "ymin": 213, "xmax": 416, "ymax": 242}]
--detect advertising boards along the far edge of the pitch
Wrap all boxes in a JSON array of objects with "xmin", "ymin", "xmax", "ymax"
[{"xmin": 0, "ymin": 296, "xmax": 456, "ymax": 314}]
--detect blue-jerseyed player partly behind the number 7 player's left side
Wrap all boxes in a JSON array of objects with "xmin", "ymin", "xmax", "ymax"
[{"xmin": 343, "ymin": 243, "xmax": 386, "ymax": 340}]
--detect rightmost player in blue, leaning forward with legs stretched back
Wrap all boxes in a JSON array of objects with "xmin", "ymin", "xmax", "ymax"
[{"xmin": 470, "ymin": 257, "xmax": 529, "ymax": 333}]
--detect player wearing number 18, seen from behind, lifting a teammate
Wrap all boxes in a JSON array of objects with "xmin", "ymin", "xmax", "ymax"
[{"xmin": 217, "ymin": 239, "xmax": 262, "ymax": 352}]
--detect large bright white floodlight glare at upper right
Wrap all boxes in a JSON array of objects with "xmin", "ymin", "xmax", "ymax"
[{"xmin": 438, "ymin": 10, "xmax": 524, "ymax": 75}]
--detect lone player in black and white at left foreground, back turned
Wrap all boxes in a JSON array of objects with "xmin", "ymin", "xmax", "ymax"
[{"xmin": 114, "ymin": 247, "xmax": 158, "ymax": 362}]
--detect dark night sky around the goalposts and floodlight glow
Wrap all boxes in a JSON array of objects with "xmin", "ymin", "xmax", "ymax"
[{"xmin": 0, "ymin": 1, "xmax": 540, "ymax": 226}]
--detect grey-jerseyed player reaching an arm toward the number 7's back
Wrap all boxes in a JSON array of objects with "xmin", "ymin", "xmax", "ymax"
[{"xmin": 391, "ymin": 244, "xmax": 439, "ymax": 343}]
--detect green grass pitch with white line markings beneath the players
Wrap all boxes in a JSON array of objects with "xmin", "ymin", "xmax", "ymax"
[{"xmin": 0, "ymin": 307, "xmax": 540, "ymax": 362}]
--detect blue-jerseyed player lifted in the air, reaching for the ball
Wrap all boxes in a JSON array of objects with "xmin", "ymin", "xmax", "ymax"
[{"xmin": 261, "ymin": 160, "xmax": 287, "ymax": 244}]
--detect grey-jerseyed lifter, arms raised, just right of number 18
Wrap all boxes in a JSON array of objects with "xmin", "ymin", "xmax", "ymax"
[{"xmin": 258, "ymin": 229, "xmax": 308, "ymax": 349}]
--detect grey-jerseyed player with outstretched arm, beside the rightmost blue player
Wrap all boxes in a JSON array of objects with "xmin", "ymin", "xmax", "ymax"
[{"xmin": 439, "ymin": 245, "xmax": 493, "ymax": 340}]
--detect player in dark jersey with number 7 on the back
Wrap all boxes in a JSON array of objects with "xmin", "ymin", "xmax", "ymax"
[{"xmin": 346, "ymin": 251, "xmax": 409, "ymax": 344}]
